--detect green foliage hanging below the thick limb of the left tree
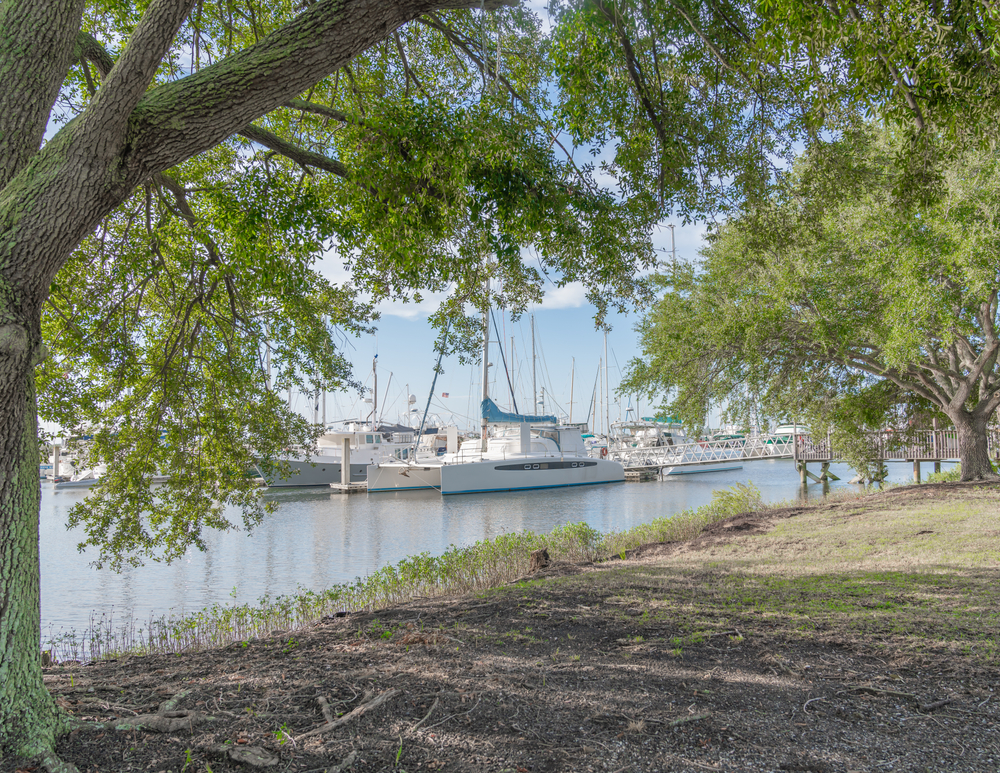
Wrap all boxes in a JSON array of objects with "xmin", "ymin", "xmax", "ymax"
[{"xmin": 36, "ymin": 2, "xmax": 654, "ymax": 568}]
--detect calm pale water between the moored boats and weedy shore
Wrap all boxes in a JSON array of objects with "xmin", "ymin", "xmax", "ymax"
[{"xmin": 41, "ymin": 460, "xmax": 944, "ymax": 635}]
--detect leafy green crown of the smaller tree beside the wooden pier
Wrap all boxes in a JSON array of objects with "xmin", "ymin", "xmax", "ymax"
[{"xmin": 623, "ymin": 125, "xmax": 1000, "ymax": 476}]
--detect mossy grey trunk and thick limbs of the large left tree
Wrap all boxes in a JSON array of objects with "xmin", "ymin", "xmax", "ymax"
[{"xmin": 0, "ymin": 0, "xmax": 516, "ymax": 755}]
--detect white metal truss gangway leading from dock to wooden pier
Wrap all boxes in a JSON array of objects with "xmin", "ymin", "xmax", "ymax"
[{"xmin": 608, "ymin": 434, "xmax": 795, "ymax": 470}]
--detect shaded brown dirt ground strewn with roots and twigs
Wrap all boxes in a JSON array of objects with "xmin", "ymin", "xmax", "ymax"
[{"xmin": 0, "ymin": 487, "xmax": 1000, "ymax": 773}]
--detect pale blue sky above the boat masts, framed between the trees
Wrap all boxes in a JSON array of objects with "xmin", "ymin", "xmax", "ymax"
[{"xmin": 308, "ymin": 219, "xmax": 704, "ymax": 428}]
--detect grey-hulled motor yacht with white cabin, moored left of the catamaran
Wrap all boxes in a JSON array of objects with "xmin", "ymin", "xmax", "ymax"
[{"xmin": 258, "ymin": 421, "xmax": 413, "ymax": 488}]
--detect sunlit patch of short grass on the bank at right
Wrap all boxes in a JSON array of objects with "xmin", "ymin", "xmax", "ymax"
[{"xmin": 554, "ymin": 484, "xmax": 1000, "ymax": 670}]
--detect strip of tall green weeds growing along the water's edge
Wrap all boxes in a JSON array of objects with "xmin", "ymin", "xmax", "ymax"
[{"xmin": 46, "ymin": 484, "xmax": 767, "ymax": 661}]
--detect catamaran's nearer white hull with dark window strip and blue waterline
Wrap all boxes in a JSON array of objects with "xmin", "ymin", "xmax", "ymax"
[{"xmin": 441, "ymin": 457, "xmax": 625, "ymax": 494}]
